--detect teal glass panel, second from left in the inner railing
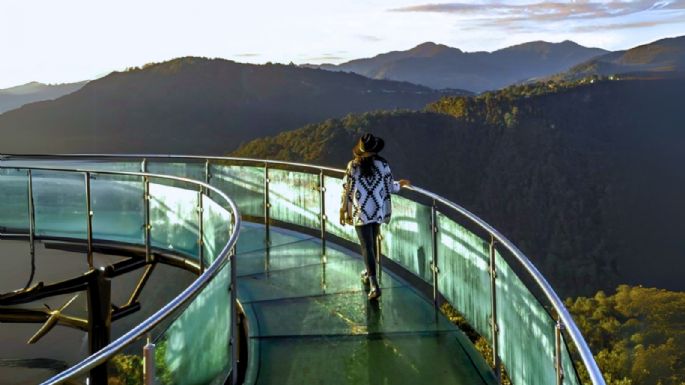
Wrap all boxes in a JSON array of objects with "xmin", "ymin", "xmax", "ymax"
[{"xmin": 33, "ymin": 170, "xmax": 88, "ymax": 239}]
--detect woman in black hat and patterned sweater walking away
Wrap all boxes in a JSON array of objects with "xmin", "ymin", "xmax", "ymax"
[{"xmin": 340, "ymin": 134, "xmax": 410, "ymax": 300}]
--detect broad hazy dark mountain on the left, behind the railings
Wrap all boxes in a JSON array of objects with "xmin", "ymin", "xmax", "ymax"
[{"xmin": 0, "ymin": 58, "xmax": 460, "ymax": 154}]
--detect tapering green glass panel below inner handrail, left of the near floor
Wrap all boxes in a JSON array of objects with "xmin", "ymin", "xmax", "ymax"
[{"xmin": 155, "ymin": 264, "xmax": 231, "ymax": 385}]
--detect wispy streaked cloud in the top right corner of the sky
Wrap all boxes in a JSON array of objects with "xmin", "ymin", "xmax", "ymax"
[{"xmin": 389, "ymin": 0, "xmax": 685, "ymax": 30}]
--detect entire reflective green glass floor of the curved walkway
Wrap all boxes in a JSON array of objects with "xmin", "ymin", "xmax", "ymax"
[{"xmin": 237, "ymin": 224, "xmax": 495, "ymax": 385}]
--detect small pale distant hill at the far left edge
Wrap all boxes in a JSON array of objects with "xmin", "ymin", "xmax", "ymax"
[{"xmin": 0, "ymin": 81, "xmax": 88, "ymax": 114}]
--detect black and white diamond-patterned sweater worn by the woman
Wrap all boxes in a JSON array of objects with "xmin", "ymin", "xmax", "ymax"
[{"xmin": 340, "ymin": 157, "xmax": 400, "ymax": 226}]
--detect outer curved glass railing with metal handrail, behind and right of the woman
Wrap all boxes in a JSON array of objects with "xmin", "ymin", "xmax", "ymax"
[{"xmin": 2, "ymin": 155, "xmax": 605, "ymax": 385}]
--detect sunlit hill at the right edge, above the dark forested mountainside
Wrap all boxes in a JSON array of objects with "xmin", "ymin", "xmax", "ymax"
[{"xmin": 562, "ymin": 36, "xmax": 685, "ymax": 79}]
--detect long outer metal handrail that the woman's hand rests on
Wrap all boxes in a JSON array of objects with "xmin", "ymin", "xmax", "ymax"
[{"xmin": 1, "ymin": 154, "xmax": 606, "ymax": 385}]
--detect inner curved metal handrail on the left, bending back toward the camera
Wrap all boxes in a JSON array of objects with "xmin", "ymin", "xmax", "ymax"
[{"xmin": 0, "ymin": 165, "xmax": 241, "ymax": 385}]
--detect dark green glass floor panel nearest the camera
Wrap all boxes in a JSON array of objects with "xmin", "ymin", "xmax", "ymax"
[{"xmin": 255, "ymin": 332, "xmax": 494, "ymax": 385}]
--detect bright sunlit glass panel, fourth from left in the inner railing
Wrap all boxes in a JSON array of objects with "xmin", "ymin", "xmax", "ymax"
[{"xmin": 150, "ymin": 178, "xmax": 199, "ymax": 257}]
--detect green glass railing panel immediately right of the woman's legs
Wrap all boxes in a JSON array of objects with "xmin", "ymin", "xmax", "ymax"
[{"xmin": 381, "ymin": 195, "xmax": 433, "ymax": 282}]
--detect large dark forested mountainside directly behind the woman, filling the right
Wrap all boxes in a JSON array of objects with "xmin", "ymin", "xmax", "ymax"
[{"xmin": 233, "ymin": 79, "xmax": 685, "ymax": 295}]
